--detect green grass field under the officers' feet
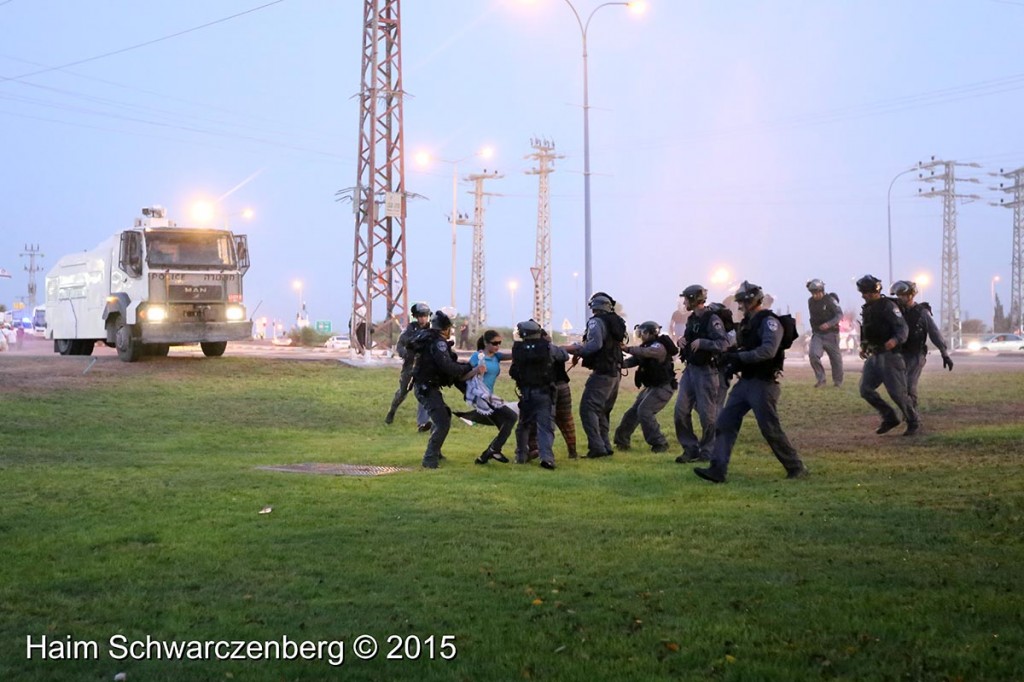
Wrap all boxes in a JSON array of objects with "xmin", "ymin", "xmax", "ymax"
[{"xmin": 0, "ymin": 356, "xmax": 1024, "ymax": 682}]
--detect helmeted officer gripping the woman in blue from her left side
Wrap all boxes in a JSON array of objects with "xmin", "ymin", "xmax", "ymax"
[{"xmin": 410, "ymin": 310, "xmax": 486, "ymax": 469}]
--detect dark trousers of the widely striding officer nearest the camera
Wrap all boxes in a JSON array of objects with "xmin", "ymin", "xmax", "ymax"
[{"xmin": 711, "ymin": 378, "xmax": 804, "ymax": 478}]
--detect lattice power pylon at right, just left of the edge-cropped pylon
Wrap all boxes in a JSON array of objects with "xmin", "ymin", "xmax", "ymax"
[{"xmin": 918, "ymin": 157, "xmax": 981, "ymax": 348}]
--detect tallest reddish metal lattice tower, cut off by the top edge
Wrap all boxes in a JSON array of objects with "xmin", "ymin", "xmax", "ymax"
[{"xmin": 351, "ymin": 0, "xmax": 409, "ymax": 352}]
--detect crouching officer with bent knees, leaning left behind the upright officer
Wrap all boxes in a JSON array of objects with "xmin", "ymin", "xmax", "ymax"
[{"xmin": 614, "ymin": 321, "xmax": 679, "ymax": 453}]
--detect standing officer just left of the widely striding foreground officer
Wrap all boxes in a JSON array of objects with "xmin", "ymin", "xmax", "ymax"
[{"xmin": 673, "ymin": 285, "xmax": 729, "ymax": 464}]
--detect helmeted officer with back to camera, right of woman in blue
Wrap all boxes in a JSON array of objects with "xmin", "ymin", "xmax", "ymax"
[{"xmin": 509, "ymin": 319, "xmax": 568, "ymax": 469}]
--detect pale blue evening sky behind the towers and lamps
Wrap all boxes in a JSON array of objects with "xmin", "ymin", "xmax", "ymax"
[{"xmin": 0, "ymin": 0, "xmax": 1024, "ymax": 331}]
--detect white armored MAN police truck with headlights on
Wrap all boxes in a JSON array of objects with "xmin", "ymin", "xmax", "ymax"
[{"xmin": 46, "ymin": 206, "xmax": 252, "ymax": 363}]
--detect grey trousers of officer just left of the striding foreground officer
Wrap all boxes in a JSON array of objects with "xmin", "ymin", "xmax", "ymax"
[{"xmin": 674, "ymin": 364, "xmax": 725, "ymax": 460}]
